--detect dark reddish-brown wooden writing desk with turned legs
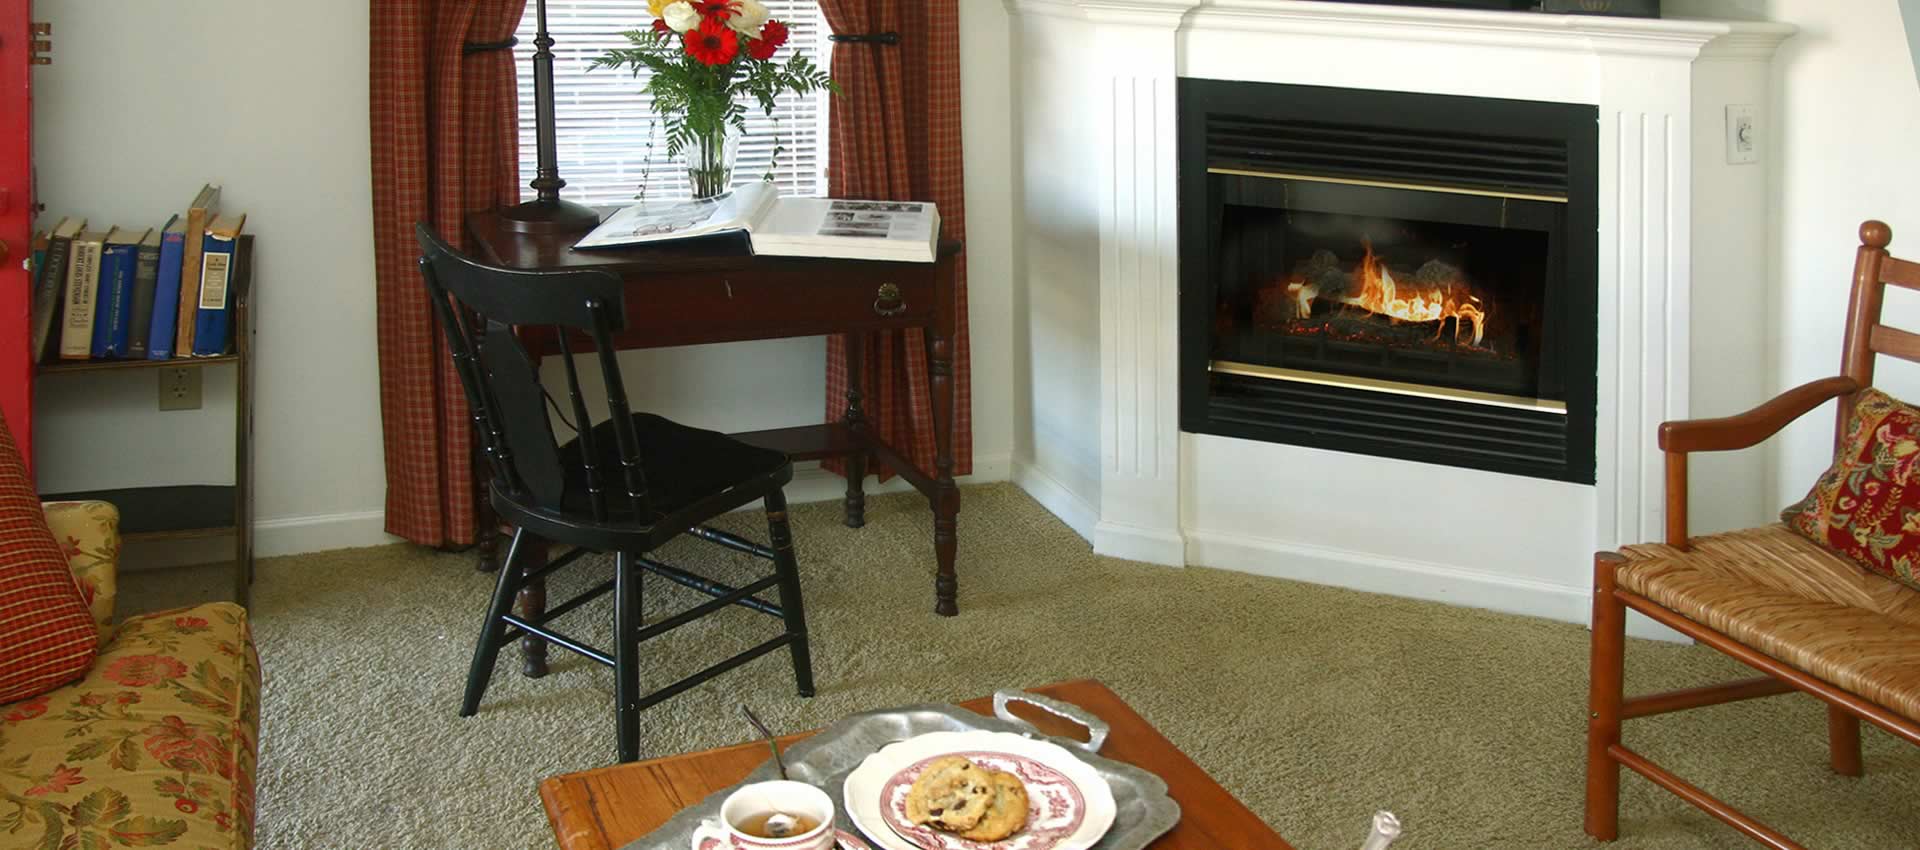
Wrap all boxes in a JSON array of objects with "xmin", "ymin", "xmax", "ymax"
[{"xmin": 467, "ymin": 213, "xmax": 960, "ymax": 675}]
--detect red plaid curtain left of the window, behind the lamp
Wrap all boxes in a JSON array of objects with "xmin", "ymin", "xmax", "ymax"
[{"xmin": 360, "ymin": 0, "xmax": 526, "ymax": 547}]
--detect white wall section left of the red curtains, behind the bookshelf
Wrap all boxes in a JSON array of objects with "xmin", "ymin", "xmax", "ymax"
[{"xmin": 33, "ymin": 0, "xmax": 384, "ymax": 553}]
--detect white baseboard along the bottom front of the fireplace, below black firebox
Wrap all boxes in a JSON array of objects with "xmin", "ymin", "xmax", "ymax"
[{"xmin": 1187, "ymin": 530, "xmax": 1688, "ymax": 643}]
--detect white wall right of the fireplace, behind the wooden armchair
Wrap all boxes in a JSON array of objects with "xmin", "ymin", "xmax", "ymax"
[{"xmin": 1676, "ymin": 0, "xmax": 1920, "ymax": 508}]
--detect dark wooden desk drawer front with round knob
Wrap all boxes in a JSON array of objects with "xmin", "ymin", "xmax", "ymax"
[{"xmin": 620, "ymin": 265, "xmax": 937, "ymax": 347}]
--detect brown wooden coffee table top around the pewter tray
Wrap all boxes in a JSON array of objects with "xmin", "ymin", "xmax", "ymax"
[{"xmin": 540, "ymin": 679, "xmax": 1292, "ymax": 850}]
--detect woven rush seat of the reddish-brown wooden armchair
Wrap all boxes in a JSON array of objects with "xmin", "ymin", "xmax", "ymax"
[{"xmin": 1615, "ymin": 524, "xmax": 1920, "ymax": 720}]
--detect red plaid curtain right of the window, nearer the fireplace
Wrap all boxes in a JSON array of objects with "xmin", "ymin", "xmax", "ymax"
[{"xmin": 820, "ymin": 0, "xmax": 973, "ymax": 476}]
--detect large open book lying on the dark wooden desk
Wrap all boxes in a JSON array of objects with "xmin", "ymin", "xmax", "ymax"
[{"xmin": 574, "ymin": 182, "xmax": 941, "ymax": 263}]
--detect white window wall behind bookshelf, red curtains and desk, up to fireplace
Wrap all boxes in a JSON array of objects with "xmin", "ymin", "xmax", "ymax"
[{"xmin": 35, "ymin": 0, "xmax": 1014, "ymax": 556}]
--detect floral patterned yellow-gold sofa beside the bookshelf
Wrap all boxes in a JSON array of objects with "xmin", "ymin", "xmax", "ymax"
[{"xmin": 0, "ymin": 503, "xmax": 259, "ymax": 850}]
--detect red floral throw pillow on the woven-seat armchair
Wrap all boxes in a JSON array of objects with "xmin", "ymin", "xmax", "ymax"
[{"xmin": 1780, "ymin": 390, "xmax": 1920, "ymax": 589}]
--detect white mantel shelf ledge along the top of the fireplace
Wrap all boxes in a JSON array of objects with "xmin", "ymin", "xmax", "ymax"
[{"xmin": 1006, "ymin": 0, "xmax": 1793, "ymax": 58}]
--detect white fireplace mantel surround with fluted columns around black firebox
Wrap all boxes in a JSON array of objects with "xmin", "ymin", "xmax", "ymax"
[{"xmin": 1006, "ymin": 0, "xmax": 1793, "ymax": 637}]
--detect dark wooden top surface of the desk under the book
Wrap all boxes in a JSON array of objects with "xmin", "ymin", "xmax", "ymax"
[{"xmin": 467, "ymin": 207, "xmax": 960, "ymax": 274}]
